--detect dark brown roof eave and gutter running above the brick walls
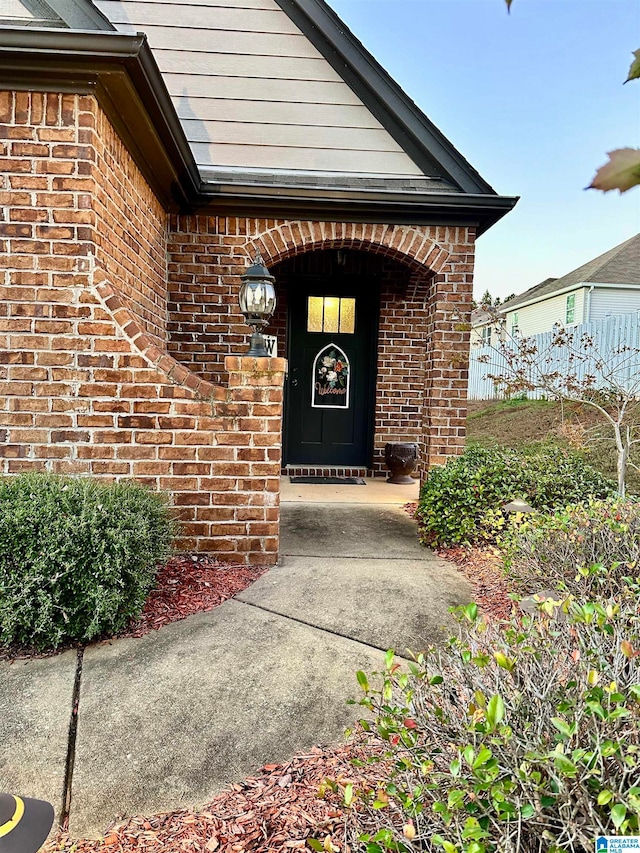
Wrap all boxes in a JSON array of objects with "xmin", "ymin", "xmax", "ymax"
[{"xmin": 0, "ymin": 28, "xmax": 518, "ymax": 234}]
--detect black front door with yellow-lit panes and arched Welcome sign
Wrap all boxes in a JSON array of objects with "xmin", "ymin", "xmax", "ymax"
[{"xmin": 285, "ymin": 277, "xmax": 378, "ymax": 467}]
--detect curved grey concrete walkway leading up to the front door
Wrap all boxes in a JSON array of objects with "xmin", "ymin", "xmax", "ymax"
[{"xmin": 0, "ymin": 481, "xmax": 470, "ymax": 837}]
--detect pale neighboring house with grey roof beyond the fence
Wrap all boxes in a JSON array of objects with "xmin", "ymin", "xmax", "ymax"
[{"xmin": 499, "ymin": 234, "xmax": 640, "ymax": 336}]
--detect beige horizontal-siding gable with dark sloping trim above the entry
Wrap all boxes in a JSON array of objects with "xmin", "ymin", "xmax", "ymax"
[{"xmin": 95, "ymin": 0, "xmax": 493, "ymax": 193}]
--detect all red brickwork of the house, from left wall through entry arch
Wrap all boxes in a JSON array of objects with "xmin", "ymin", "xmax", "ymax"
[{"xmin": 0, "ymin": 88, "xmax": 474, "ymax": 562}]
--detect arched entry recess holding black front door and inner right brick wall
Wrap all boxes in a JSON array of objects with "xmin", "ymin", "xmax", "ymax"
[{"xmin": 270, "ymin": 248, "xmax": 431, "ymax": 474}]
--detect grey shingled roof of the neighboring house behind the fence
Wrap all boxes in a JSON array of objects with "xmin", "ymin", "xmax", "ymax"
[{"xmin": 500, "ymin": 234, "xmax": 640, "ymax": 313}]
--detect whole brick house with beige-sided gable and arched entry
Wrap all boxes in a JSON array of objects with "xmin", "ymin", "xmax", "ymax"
[{"xmin": 0, "ymin": 0, "xmax": 516, "ymax": 563}]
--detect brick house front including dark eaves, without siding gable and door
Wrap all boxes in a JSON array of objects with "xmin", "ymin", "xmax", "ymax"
[{"xmin": 0, "ymin": 8, "xmax": 514, "ymax": 564}]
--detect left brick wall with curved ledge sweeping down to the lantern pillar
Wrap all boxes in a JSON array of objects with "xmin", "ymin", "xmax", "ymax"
[{"xmin": 0, "ymin": 93, "xmax": 285, "ymax": 563}]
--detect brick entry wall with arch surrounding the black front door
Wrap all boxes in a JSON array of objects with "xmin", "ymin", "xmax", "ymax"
[{"xmin": 168, "ymin": 216, "xmax": 474, "ymax": 474}]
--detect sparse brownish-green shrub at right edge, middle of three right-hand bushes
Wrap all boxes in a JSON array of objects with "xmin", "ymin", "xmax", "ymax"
[{"xmin": 502, "ymin": 498, "xmax": 640, "ymax": 597}]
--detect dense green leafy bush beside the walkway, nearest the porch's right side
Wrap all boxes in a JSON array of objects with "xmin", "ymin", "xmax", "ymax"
[{"xmin": 416, "ymin": 445, "xmax": 615, "ymax": 545}]
